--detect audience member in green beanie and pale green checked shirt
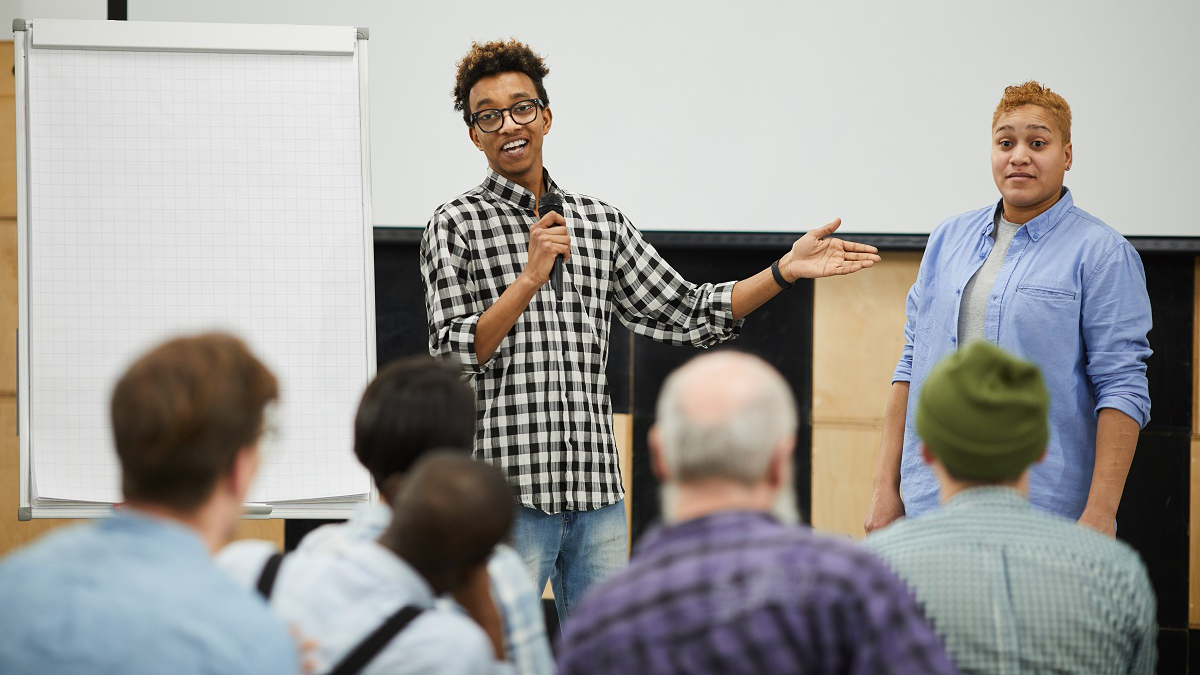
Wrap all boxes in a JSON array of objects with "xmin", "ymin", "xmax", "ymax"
[{"xmin": 866, "ymin": 341, "xmax": 1158, "ymax": 675}]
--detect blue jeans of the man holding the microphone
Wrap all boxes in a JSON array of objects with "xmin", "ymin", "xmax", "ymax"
[{"xmin": 512, "ymin": 500, "xmax": 629, "ymax": 625}]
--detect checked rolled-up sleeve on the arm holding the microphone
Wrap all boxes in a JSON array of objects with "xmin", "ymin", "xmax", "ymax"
[{"xmin": 420, "ymin": 214, "xmax": 499, "ymax": 374}]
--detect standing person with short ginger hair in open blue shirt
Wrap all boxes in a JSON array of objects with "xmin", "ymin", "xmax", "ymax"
[{"xmin": 864, "ymin": 82, "xmax": 1151, "ymax": 536}]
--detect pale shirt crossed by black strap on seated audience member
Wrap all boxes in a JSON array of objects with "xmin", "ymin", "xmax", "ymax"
[{"xmin": 217, "ymin": 533, "xmax": 512, "ymax": 675}]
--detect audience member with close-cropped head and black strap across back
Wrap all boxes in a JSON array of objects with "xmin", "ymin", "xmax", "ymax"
[{"xmin": 225, "ymin": 452, "xmax": 514, "ymax": 675}]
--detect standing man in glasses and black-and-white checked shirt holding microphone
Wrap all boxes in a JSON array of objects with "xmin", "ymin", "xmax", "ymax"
[{"xmin": 421, "ymin": 35, "xmax": 880, "ymax": 617}]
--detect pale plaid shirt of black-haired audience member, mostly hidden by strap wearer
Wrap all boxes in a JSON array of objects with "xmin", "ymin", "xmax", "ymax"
[{"xmin": 296, "ymin": 503, "xmax": 554, "ymax": 675}]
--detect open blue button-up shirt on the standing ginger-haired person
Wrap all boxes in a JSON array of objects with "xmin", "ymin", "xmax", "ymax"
[{"xmin": 893, "ymin": 190, "xmax": 1151, "ymax": 520}]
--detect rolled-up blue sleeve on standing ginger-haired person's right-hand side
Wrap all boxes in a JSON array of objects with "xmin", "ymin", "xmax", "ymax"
[{"xmin": 1080, "ymin": 241, "xmax": 1152, "ymax": 426}]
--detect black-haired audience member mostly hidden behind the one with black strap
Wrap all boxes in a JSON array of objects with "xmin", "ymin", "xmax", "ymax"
[{"xmin": 218, "ymin": 356, "xmax": 553, "ymax": 675}]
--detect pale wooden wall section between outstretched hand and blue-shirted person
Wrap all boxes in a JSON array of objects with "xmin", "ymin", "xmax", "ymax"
[{"xmin": 811, "ymin": 251, "xmax": 920, "ymax": 537}]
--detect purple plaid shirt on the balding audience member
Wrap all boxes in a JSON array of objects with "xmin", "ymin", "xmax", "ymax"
[{"xmin": 559, "ymin": 512, "xmax": 955, "ymax": 675}]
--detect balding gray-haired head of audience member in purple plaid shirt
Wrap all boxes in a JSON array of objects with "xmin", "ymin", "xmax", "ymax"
[{"xmin": 656, "ymin": 352, "xmax": 797, "ymax": 485}]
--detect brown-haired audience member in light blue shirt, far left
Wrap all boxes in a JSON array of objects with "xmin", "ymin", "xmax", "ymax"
[{"xmin": 0, "ymin": 334, "xmax": 299, "ymax": 675}]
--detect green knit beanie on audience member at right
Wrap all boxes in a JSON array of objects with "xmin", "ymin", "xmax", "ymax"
[{"xmin": 917, "ymin": 340, "xmax": 1050, "ymax": 482}]
